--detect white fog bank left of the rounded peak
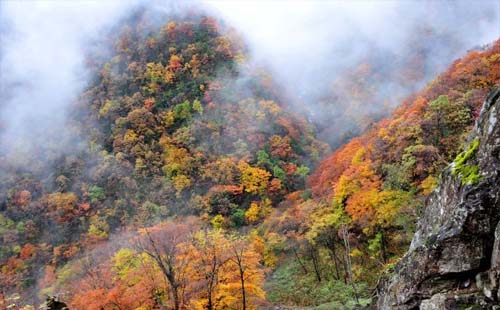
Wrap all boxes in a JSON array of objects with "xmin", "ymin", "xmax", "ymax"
[{"xmin": 0, "ymin": 1, "xmax": 142, "ymax": 165}]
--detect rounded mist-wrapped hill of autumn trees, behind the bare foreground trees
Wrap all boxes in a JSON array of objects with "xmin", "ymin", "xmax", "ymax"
[{"xmin": 0, "ymin": 11, "xmax": 328, "ymax": 309}]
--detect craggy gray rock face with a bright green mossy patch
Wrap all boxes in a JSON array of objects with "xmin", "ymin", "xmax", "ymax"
[{"xmin": 374, "ymin": 89, "xmax": 500, "ymax": 310}]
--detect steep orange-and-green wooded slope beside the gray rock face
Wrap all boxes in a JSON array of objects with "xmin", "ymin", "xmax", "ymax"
[{"xmin": 262, "ymin": 41, "xmax": 500, "ymax": 309}]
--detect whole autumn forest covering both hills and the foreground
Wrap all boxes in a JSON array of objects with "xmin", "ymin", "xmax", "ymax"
[{"xmin": 0, "ymin": 2, "xmax": 500, "ymax": 310}]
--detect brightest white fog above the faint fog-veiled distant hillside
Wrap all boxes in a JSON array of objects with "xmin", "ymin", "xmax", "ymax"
[{"xmin": 208, "ymin": 0, "xmax": 500, "ymax": 92}]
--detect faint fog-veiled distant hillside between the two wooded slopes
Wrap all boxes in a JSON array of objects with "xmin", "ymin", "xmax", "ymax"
[{"xmin": 312, "ymin": 25, "xmax": 474, "ymax": 148}]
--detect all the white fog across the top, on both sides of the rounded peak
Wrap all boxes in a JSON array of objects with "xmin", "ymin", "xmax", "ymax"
[{"xmin": 0, "ymin": 0, "xmax": 500, "ymax": 161}]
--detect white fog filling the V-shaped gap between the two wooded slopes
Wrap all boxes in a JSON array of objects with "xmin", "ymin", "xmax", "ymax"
[{"xmin": 208, "ymin": 0, "xmax": 500, "ymax": 147}]
